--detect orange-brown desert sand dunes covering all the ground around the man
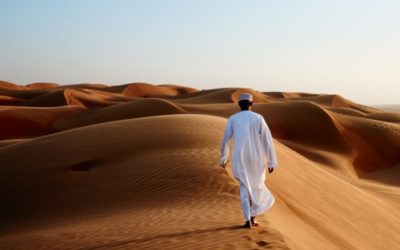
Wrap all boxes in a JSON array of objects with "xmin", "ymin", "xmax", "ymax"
[{"xmin": 0, "ymin": 81, "xmax": 400, "ymax": 250}]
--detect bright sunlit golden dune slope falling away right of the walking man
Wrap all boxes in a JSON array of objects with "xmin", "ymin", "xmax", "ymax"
[{"xmin": 267, "ymin": 142, "xmax": 400, "ymax": 249}]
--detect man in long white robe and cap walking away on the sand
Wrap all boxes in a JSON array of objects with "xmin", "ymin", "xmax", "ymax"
[{"xmin": 220, "ymin": 93, "xmax": 278, "ymax": 228}]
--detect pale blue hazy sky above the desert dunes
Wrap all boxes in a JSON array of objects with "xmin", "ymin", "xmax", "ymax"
[{"xmin": 0, "ymin": 0, "xmax": 400, "ymax": 105}]
